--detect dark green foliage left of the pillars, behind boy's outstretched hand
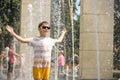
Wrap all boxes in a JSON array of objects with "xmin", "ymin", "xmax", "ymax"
[{"xmin": 0, "ymin": 0, "xmax": 20, "ymax": 50}]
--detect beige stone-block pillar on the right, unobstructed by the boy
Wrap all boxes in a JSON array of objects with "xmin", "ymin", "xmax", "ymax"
[{"xmin": 79, "ymin": 0, "xmax": 114, "ymax": 80}]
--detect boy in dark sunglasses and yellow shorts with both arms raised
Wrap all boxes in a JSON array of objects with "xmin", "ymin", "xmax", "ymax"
[{"xmin": 6, "ymin": 21, "xmax": 66, "ymax": 80}]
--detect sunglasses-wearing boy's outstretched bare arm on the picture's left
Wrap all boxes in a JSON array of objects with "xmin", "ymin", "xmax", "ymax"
[{"xmin": 6, "ymin": 25, "xmax": 30, "ymax": 43}]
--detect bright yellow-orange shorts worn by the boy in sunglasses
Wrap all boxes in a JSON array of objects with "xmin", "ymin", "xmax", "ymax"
[{"xmin": 33, "ymin": 67, "xmax": 50, "ymax": 80}]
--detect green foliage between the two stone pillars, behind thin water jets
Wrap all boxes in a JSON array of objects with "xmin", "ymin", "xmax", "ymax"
[{"xmin": 65, "ymin": 0, "xmax": 80, "ymax": 61}]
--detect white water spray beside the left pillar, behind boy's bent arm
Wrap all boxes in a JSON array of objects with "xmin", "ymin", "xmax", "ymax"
[{"xmin": 51, "ymin": 0, "xmax": 63, "ymax": 80}]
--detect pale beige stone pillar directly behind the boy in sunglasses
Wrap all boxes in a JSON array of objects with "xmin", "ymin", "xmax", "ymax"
[{"xmin": 20, "ymin": 0, "xmax": 50, "ymax": 80}]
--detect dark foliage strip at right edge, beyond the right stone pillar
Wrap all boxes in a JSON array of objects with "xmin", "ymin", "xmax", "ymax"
[{"xmin": 113, "ymin": 0, "xmax": 120, "ymax": 78}]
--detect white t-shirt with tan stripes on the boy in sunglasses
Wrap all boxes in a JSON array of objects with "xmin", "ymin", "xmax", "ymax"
[{"xmin": 29, "ymin": 37, "xmax": 56, "ymax": 68}]
